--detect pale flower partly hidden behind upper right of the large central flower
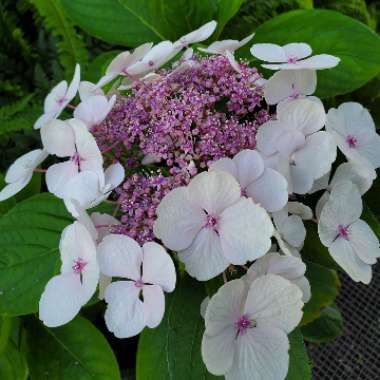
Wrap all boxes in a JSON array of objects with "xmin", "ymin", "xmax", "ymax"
[{"xmin": 210, "ymin": 149, "xmax": 288, "ymax": 212}]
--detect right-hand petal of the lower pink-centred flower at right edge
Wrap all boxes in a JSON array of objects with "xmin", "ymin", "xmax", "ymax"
[{"xmin": 348, "ymin": 219, "xmax": 380, "ymax": 264}]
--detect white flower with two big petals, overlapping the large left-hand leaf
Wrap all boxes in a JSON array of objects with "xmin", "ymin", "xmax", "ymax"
[{"xmin": 39, "ymin": 222, "xmax": 99, "ymax": 327}]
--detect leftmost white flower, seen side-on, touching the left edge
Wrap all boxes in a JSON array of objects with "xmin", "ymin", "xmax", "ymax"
[{"xmin": 0, "ymin": 149, "xmax": 48, "ymax": 201}]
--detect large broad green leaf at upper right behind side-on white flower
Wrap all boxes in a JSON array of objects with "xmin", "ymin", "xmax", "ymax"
[{"xmin": 245, "ymin": 10, "xmax": 380, "ymax": 98}]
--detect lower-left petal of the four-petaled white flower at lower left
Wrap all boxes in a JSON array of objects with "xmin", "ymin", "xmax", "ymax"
[{"xmin": 104, "ymin": 281, "xmax": 146, "ymax": 338}]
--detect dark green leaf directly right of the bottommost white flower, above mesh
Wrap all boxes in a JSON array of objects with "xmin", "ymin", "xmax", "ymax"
[{"xmin": 301, "ymin": 262, "xmax": 340, "ymax": 325}]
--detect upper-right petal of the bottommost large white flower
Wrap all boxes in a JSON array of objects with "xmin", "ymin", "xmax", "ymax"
[{"xmin": 244, "ymin": 274, "xmax": 303, "ymax": 333}]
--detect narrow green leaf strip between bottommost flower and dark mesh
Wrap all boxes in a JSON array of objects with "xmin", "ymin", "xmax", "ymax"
[{"xmin": 286, "ymin": 328, "xmax": 311, "ymax": 380}]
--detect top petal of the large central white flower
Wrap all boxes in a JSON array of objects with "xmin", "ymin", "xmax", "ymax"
[{"xmin": 187, "ymin": 171, "xmax": 241, "ymax": 216}]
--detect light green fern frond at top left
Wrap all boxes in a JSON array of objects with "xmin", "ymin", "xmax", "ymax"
[{"xmin": 29, "ymin": 0, "xmax": 88, "ymax": 78}]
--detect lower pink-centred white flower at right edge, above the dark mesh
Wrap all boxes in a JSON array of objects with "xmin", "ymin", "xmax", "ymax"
[{"xmin": 318, "ymin": 181, "xmax": 380, "ymax": 284}]
